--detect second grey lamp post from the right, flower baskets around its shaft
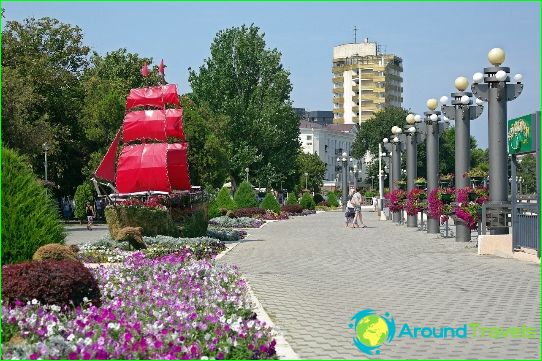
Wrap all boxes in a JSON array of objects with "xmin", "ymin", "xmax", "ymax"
[{"xmin": 440, "ymin": 76, "xmax": 484, "ymax": 242}]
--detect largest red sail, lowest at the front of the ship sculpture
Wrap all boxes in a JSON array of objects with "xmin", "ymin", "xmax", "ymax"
[{"xmin": 116, "ymin": 143, "xmax": 171, "ymax": 193}]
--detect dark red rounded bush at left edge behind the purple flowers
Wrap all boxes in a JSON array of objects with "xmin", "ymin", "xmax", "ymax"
[{"xmin": 2, "ymin": 260, "xmax": 101, "ymax": 306}]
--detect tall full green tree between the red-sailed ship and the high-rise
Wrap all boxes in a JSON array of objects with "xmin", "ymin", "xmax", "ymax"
[{"xmin": 189, "ymin": 25, "xmax": 299, "ymax": 188}]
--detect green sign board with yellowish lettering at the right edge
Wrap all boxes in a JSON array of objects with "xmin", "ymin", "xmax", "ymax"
[{"xmin": 507, "ymin": 114, "xmax": 536, "ymax": 154}]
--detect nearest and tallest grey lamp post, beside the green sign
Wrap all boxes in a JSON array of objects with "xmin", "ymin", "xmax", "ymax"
[{"xmin": 471, "ymin": 48, "xmax": 523, "ymax": 234}]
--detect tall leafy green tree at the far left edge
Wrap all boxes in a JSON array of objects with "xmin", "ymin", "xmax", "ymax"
[{"xmin": 2, "ymin": 18, "xmax": 89, "ymax": 192}]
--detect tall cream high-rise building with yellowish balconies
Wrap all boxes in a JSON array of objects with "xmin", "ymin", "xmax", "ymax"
[{"xmin": 332, "ymin": 38, "xmax": 403, "ymax": 124}]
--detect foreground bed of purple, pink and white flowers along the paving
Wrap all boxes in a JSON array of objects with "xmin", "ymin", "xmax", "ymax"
[{"xmin": 2, "ymin": 249, "xmax": 276, "ymax": 359}]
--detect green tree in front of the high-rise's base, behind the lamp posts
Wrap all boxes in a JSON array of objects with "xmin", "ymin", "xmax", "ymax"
[{"xmin": 352, "ymin": 107, "xmax": 408, "ymax": 159}]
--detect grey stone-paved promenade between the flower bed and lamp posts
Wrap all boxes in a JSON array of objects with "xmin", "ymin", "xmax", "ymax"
[{"xmin": 220, "ymin": 212, "xmax": 540, "ymax": 359}]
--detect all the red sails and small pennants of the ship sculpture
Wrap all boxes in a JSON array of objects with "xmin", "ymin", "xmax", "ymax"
[{"xmin": 95, "ymin": 61, "xmax": 191, "ymax": 194}]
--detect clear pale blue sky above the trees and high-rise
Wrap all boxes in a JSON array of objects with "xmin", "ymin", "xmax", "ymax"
[{"xmin": 2, "ymin": 2, "xmax": 540, "ymax": 148}]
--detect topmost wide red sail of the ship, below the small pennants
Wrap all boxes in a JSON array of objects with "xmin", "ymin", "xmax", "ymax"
[{"xmin": 126, "ymin": 84, "xmax": 180, "ymax": 110}]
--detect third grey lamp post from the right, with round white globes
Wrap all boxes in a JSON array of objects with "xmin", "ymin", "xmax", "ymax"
[{"xmin": 424, "ymin": 99, "xmax": 446, "ymax": 234}]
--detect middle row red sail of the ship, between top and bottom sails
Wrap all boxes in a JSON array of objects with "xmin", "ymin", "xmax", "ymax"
[{"xmin": 122, "ymin": 109, "xmax": 184, "ymax": 142}]
